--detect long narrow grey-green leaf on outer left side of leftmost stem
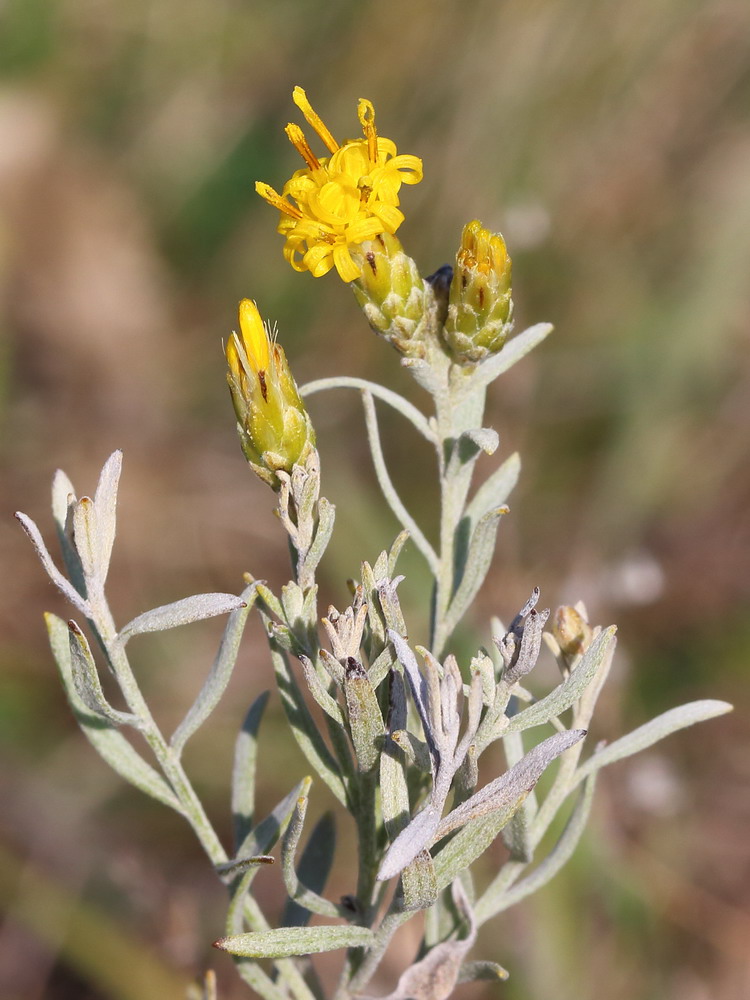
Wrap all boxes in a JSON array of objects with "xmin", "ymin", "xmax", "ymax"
[{"xmin": 45, "ymin": 614, "xmax": 183, "ymax": 813}]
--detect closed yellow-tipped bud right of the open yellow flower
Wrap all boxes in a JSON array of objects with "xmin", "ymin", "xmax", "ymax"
[{"xmin": 444, "ymin": 219, "xmax": 513, "ymax": 365}]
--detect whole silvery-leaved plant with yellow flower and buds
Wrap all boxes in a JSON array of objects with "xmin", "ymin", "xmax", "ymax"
[{"xmin": 17, "ymin": 88, "xmax": 730, "ymax": 1000}]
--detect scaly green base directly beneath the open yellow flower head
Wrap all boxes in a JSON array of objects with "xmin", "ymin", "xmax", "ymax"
[{"xmin": 352, "ymin": 233, "xmax": 435, "ymax": 357}]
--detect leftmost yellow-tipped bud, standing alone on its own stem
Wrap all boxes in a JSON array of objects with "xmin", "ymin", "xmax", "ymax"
[{"xmin": 226, "ymin": 299, "xmax": 315, "ymax": 489}]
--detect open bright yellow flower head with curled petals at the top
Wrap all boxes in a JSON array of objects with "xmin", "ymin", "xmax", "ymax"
[{"xmin": 255, "ymin": 87, "xmax": 422, "ymax": 281}]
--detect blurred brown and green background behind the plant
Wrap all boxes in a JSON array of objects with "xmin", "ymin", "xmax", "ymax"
[{"xmin": 0, "ymin": 0, "xmax": 750, "ymax": 1000}]
